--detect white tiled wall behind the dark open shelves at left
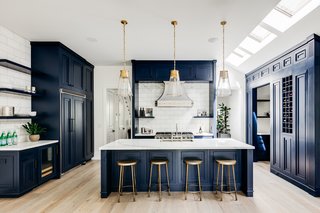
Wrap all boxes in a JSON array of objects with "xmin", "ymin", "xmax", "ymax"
[{"xmin": 0, "ymin": 26, "xmax": 31, "ymax": 142}]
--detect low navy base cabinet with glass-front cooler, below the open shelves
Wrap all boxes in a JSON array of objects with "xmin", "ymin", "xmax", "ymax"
[{"xmin": 0, "ymin": 143, "xmax": 58, "ymax": 197}]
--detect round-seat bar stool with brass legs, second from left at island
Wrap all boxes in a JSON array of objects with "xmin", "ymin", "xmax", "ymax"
[{"xmin": 148, "ymin": 159, "xmax": 170, "ymax": 201}]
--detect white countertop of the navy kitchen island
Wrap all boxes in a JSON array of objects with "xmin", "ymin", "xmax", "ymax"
[{"xmin": 100, "ymin": 138, "xmax": 254, "ymax": 150}]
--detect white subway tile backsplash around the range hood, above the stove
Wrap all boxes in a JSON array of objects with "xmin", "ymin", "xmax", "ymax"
[{"xmin": 139, "ymin": 83, "xmax": 212, "ymax": 133}]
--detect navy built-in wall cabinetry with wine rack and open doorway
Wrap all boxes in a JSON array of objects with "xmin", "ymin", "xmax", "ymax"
[{"xmin": 246, "ymin": 35, "xmax": 320, "ymax": 196}]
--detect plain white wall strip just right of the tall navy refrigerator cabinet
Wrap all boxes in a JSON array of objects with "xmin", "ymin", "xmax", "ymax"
[{"xmin": 94, "ymin": 66, "xmax": 131, "ymax": 159}]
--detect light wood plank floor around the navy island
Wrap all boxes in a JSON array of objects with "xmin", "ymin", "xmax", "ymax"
[{"xmin": 0, "ymin": 161, "xmax": 320, "ymax": 213}]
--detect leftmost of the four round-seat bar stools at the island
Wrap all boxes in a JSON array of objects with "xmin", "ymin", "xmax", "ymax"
[{"xmin": 117, "ymin": 160, "xmax": 137, "ymax": 203}]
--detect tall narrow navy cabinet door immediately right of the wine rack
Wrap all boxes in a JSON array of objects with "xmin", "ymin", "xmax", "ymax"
[{"xmin": 294, "ymin": 71, "xmax": 308, "ymax": 181}]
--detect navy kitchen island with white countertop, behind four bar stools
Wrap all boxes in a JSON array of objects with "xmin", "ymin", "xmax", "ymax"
[{"xmin": 100, "ymin": 139, "xmax": 254, "ymax": 198}]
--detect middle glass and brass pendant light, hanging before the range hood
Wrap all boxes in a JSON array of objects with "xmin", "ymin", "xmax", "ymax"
[{"xmin": 168, "ymin": 20, "xmax": 183, "ymax": 96}]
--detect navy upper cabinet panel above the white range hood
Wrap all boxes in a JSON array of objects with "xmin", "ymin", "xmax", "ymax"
[{"xmin": 132, "ymin": 60, "xmax": 215, "ymax": 82}]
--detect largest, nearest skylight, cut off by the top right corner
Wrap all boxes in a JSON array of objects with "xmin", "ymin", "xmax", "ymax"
[{"xmin": 262, "ymin": 0, "xmax": 320, "ymax": 32}]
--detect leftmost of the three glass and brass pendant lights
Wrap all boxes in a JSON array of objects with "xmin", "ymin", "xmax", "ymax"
[{"xmin": 118, "ymin": 20, "xmax": 132, "ymax": 98}]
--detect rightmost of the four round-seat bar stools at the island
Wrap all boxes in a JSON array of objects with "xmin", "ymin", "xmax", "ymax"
[{"xmin": 216, "ymin": 160, "xmax": 238, "ymax": 201}]
